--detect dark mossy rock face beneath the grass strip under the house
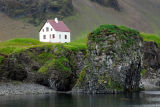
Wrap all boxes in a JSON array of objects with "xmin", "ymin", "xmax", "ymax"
[{"xmin": 0, "ymin": 45, "xmax": 85, "ymax": 91}]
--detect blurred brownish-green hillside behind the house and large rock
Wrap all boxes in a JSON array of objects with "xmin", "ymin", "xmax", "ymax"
[{"xmin": 0, "ymin": 0, "xmax": 160, "ymax": 40}]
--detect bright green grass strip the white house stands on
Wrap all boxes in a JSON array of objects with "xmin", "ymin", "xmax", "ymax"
[{"xmin": 0, "ymin": 38, "xmax": 86, "ymax": 55}]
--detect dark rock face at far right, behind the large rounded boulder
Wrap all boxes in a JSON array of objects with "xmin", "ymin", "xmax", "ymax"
[{"xmin": 142, "ymin": 42, "xmax": 160, "ymax": 90}]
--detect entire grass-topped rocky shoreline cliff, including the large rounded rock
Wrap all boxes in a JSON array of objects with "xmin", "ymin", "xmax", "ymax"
[{"xmin": 0, "ymin": 25, "xmax": 160, "ymax": 93}]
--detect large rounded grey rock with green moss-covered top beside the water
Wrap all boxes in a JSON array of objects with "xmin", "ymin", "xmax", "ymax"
[{"xmin": 75, "ymin": 25, "xmax": 143, "ymax": 93}]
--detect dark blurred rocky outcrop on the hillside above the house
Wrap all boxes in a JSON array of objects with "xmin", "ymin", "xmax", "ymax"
[{"xmin": 0, "ymin": 0, "xmax": 73, "ymax": 25}]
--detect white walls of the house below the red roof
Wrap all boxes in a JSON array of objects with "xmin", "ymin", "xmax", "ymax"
[{"xmin": 39, "ymin": 22, "xmax": 71, "ymax": 43}]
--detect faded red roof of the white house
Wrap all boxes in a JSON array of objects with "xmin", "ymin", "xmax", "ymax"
[{"xmin": 47, "ymin": 20, "xmax": 70, "ymax": 32}]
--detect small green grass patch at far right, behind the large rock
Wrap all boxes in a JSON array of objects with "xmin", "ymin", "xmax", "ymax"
[{"xmin": 140, "ymin": 33, "xmax": 160, "ymax": 47}]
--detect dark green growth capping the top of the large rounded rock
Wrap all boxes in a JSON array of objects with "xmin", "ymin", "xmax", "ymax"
[{"xmin": 88, "ymin": 24, "xmax": 139, "ymax": 49}]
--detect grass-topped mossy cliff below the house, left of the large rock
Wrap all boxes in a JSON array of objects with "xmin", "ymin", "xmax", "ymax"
[{"xmin": 0, "ymin": 38, "xmax": 86, "ymax": 91}]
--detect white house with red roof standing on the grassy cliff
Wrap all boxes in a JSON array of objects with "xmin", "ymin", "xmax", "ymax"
[{"xmin": 39, "ymin": 18, "xmax": 70, "ymax": 43}]
